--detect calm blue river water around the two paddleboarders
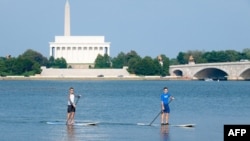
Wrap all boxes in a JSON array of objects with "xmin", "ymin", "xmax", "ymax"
[{"xmin": 0, "ymin": 81, "xmax": 250, "ymax": 141}]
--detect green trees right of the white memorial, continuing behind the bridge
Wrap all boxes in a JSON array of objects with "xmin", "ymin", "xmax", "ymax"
[{"xmin": 95, "ymin": 49, "xmax": 250, "ymax": 76}]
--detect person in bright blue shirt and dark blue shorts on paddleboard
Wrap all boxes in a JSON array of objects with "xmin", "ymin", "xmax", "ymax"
[{"xmin": 161, "ymin": 87, "xmax": 174, "ymax": 125}]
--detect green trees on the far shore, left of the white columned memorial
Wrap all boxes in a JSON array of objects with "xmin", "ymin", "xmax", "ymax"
[{"xmin": 0, "ymin": 49, "xmax": 67, "ymax": 76}]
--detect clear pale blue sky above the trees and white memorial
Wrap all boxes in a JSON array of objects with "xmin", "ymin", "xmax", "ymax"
[{"xmin": 0, "ymin": 0, "xmax": 250, "ymax": 58}]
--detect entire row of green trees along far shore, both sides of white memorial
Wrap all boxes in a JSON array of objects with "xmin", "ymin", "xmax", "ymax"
[{"xmin": 0, "ymin": 48, "xmax": 250, "ymax": 76}]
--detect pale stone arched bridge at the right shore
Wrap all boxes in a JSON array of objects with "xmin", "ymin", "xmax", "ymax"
[{"xmin": 169, "ymin": 61, "xmax": 250, "ymax": 80}]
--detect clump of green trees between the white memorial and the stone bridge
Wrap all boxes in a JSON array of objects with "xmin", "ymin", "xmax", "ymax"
[{"xmin": 94, "ymin": 50, "xmax": 170, "ymax": 76}]
